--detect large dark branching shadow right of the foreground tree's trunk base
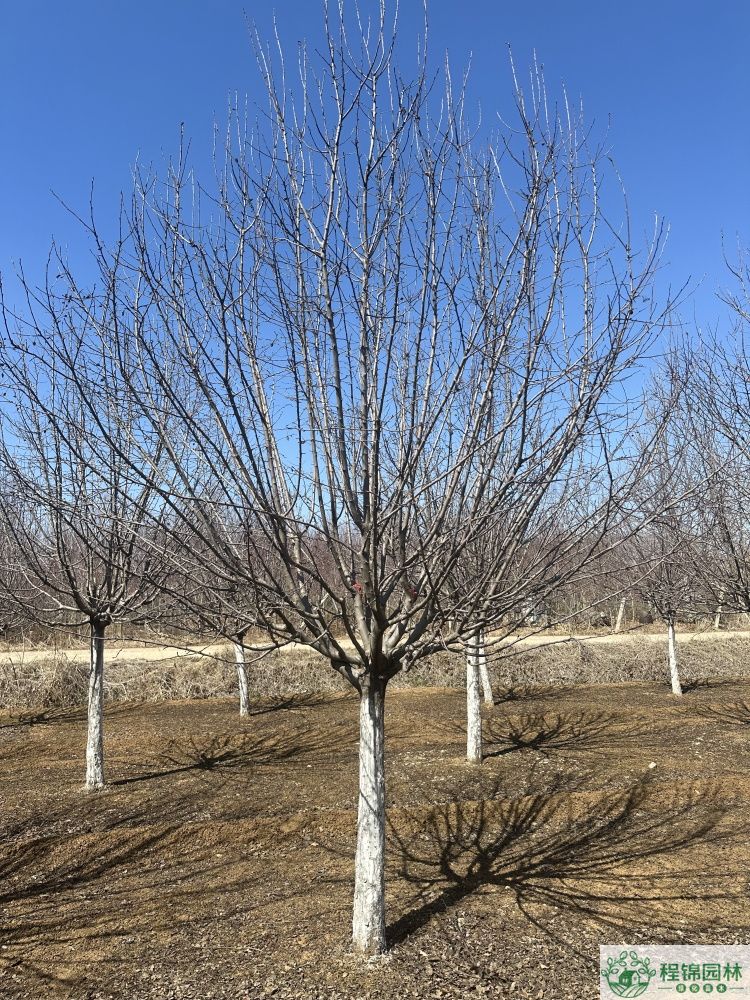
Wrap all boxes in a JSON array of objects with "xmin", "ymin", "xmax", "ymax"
[{"xmin": 389, "ymin": 778, "xmax": 750, "ymax": 943}]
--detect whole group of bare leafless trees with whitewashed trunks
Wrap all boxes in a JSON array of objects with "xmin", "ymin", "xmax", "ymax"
[{"xmin": 0, "ymin": 9, "xmax": 750, "ymax": 953}]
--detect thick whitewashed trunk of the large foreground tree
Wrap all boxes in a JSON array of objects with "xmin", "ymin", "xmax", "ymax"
[{"xmin": 352, "ymin": 678, "xmax": 385, "ymax": 955}]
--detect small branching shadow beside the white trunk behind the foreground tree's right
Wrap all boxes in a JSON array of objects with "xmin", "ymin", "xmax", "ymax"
[{"xmin": 485, "ymin": 712, "xmax": 653, "ymax": 757}]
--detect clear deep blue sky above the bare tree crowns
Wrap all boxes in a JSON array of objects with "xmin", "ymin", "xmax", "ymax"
[{"xmin": 0, "ymin": 0, "xmax": 750, "ymax": 323}]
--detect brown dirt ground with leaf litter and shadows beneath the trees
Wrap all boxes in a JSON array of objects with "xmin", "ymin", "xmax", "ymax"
[{"xmin": 0, "ymin": 679, "xmax": 750, "ymax": 1000}]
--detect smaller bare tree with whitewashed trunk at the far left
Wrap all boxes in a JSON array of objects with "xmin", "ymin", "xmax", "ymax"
[{"xmin": 0, "ymin": 318, "xmax": 172, "ymax": 791}]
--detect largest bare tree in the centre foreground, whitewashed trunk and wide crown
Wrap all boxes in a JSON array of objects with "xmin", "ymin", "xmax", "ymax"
[{"xmin": 4, "ymin": 8, "xmax": 661, "ymax": 954}]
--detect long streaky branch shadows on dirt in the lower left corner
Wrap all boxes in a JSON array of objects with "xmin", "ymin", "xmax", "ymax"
[{"xmin": 0, "ymin": 811, "xmax": 291, "ymax": 996}]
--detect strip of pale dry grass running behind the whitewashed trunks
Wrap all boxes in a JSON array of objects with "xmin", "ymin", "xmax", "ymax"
[{"xmin": 0, "ymin": 636, "xmax": 750, "ymax": 709}]
